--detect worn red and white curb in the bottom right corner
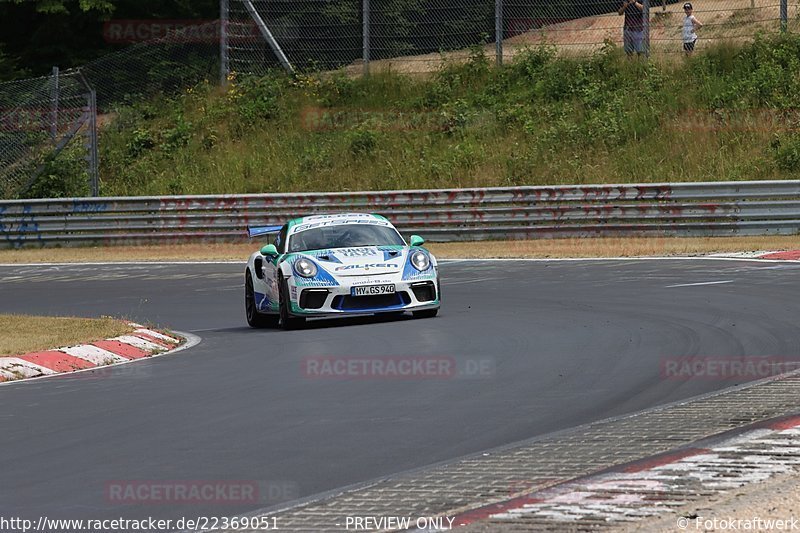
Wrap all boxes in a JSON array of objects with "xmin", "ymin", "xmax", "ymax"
[{"xmin": 456, "ymin": 416, "xmax": 800, "ymax": 529}]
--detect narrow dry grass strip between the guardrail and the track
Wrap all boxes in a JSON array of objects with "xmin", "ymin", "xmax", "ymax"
[{"xmin": 0, "ymin": 236, "xmax": 800, "ymax": 264}]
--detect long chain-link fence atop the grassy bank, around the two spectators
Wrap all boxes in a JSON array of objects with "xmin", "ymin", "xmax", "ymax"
[{"xmin": 221, "ymin": 0, "xmax": 798, "ymax": 73}]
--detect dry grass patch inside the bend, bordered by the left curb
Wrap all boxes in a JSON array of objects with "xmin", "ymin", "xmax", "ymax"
[{"xmin": 0, "ymin": 315, "xmax": 133, "ymax": 357}]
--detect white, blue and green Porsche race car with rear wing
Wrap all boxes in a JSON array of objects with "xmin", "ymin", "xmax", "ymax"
[{"xmin": 244, "ymin": 213, "xmax": 440, "ymax": 329}]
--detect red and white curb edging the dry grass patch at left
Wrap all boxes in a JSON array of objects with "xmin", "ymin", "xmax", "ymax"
[{"xmin": 0, "ymin": 323, "xmax": 185, "ymax": 382}]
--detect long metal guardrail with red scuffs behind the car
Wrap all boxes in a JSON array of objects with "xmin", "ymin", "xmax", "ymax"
[{"xmin": 0, "ymin": 181, "xmax": 800, "ymax": 247}]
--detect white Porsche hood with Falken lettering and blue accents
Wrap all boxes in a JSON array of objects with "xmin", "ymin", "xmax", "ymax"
[{"xmin": 298, "ymin": 246, "xmax": 408, "ymax": 277}]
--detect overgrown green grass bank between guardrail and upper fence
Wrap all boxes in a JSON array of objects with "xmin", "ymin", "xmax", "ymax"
[{"xmin": 29, "ymin": 35, "xmax": 800, "ymax": 195}]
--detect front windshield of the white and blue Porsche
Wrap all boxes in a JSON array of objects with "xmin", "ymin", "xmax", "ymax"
[{"xmin": 289, "ymin": 224, "xmax": 405, "ymax": 252}]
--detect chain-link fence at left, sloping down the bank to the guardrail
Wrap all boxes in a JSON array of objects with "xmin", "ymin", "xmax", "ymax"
[{"xmin": 0, "ymin": 20, "xmax": 220, "ymax": 198}]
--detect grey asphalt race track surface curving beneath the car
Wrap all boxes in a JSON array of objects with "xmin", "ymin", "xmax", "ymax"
[{"xmin": 0, "ymin": 260, "xmax": 800, "ymax": 519}]
